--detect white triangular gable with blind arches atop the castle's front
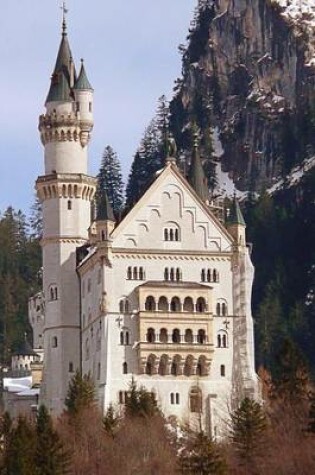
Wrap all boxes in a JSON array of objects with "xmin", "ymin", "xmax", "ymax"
[{"xmin": 112, "ymin": 166, "xmax": 232, "ymax": 252}]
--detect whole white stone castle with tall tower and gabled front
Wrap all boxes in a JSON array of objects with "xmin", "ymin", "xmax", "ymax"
[{"xmin": 30, "ymin": 16, "xmax": 258, "ymax": 436}]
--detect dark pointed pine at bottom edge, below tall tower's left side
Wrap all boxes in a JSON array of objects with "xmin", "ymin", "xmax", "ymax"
[{"xmin": 35, "ymin": 406, "xmax": 69, "ymax": 475}]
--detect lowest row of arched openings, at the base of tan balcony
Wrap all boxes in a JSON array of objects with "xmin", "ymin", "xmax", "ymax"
[{"xmin": 144, "ymin": 354, "xmax": 209, "ymax": 377}]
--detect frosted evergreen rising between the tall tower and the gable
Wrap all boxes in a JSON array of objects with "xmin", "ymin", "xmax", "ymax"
[{"xmin": 97, "ymin": 145, "xmax": 124, "ymax": 215}]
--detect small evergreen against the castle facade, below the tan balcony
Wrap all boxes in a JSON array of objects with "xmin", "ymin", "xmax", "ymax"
[{"xmin": 126, "ymin": 378, "xmax": 159, "ymax": 417}]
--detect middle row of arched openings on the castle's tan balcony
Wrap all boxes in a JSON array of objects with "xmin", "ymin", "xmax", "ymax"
[{"xmin": 146, "ymin": 328, "xmax": 207, "ymax": 345}]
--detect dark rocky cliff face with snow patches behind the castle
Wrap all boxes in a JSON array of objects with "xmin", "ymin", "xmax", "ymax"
[{"xmin": 171, "ymin": 0, "xmax": 315, "ymax": 191}]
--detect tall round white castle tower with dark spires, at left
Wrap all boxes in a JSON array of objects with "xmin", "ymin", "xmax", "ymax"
[{"xmin": 36, "ymin": 14, "xmax": 96, "ymax": 414}]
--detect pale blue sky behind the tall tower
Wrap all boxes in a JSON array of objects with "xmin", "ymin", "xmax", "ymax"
[{"xmin": 0, "ymin": 0, "xmax": 197, "ymax": 213}]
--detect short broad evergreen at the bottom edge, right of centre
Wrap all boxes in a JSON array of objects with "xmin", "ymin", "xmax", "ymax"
[{"xmin": 179, "ymin": 432, "xmax": 227, "ymax": 475}]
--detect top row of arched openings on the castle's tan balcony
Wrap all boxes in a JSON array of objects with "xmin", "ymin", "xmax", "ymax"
[{"xmin": 145, "ymin": 295, "xmax": 207, "ymax": 313}]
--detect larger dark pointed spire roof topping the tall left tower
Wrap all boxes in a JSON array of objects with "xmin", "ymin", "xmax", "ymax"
[{"xmin": 46, "ymin": 19, "xmax": 75, "ymax": 103}]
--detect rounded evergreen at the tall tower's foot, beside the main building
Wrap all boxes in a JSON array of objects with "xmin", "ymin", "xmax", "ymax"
[{"xmin": 65, "ymin": 371, "xmax": 95, "ymax": 416}]
